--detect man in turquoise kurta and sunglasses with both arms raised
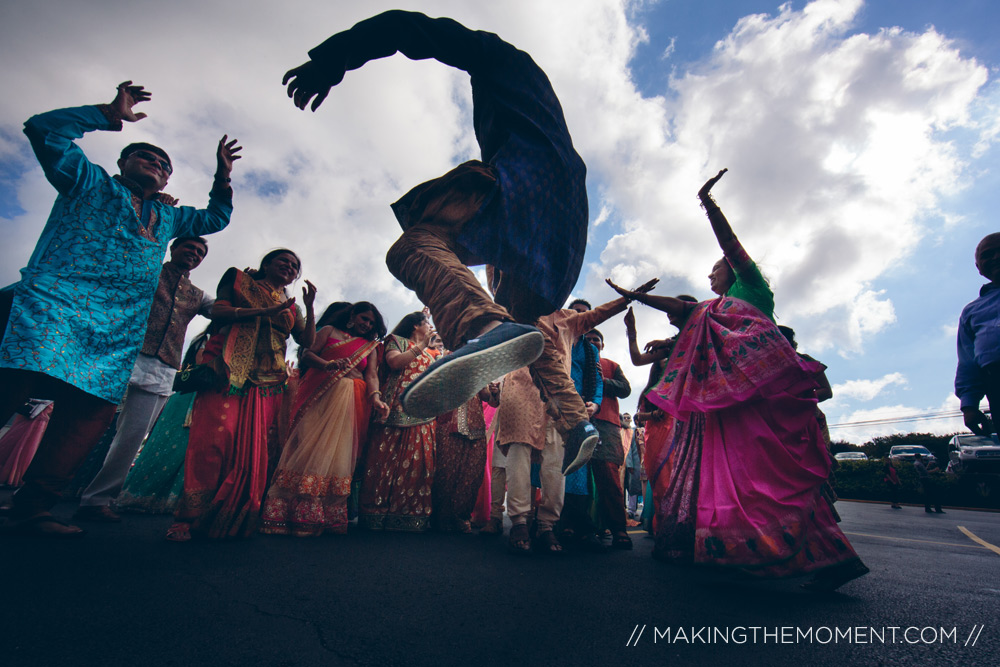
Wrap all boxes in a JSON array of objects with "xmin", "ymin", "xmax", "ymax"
[{"xmin": 0, "ymin": 81, "xmax": 240, "ymax": 536}]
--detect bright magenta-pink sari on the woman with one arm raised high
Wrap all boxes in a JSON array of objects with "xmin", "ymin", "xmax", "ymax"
[{"xmin": 646, "ymin": 297, "xmax": 860, "ymax": 577}]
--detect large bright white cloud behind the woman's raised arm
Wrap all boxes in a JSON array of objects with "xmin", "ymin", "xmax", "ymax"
[{"xmin": 590, "ymin": 0, "xmax": 987, "ymax": 353}]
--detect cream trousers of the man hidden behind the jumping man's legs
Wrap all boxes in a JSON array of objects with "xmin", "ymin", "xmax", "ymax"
[{"xmin": 507, "ymin": 422, "xmax": 566, "ymax": 533}]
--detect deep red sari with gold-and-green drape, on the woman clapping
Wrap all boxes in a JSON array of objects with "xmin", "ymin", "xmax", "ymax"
[{"xmin": 175, "ymin": 268, "xmax": 305, "ymax": 538}]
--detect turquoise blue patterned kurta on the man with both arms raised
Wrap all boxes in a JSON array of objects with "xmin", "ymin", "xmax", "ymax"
[{"xmin": 0, "ymin": 106, "xmax": 232, "ymax": 403}]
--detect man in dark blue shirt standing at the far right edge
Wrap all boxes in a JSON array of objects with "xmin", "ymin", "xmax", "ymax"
[{"xmin": 955, "ymin": 233, "xmax": 1000, "ymax": 435}]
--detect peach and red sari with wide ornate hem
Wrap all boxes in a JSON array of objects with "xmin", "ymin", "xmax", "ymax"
[{"xmin": 260, "ymin": 338, "xmax": 378, "ymax": 537}]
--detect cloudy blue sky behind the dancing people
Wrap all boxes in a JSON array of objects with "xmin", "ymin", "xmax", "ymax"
[{"xmin": 0, "ymin": 0, "xmax": 1000, "ymax": 442}]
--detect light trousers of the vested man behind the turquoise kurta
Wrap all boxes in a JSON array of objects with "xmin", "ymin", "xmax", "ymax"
[{"xmin": 80, "ymin": 384, "xmax": 169, "ymax": 507}]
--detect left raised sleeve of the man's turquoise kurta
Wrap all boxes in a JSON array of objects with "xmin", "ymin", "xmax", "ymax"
[{"xmin": 24, "ymin": 106, "xmax": 121, "ymax": 196}]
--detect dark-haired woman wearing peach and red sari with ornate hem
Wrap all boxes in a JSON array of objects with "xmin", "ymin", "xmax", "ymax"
[{"xmin": 260, "ymin": 301, "xmax": 389, "ymax": 537}]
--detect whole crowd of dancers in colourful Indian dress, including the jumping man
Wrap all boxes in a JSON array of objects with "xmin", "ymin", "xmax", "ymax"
[{"xmin": 11, "ymin": 11, "xmax": 996, "ymax": 591}]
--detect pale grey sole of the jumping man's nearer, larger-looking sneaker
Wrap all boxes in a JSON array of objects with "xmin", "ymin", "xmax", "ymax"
[{"xmin": 403, "ymin": 331, "xmax": 545, "ymax": 418}]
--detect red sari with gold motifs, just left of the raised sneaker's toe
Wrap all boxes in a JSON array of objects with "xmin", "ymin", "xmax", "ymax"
[{"xmin": 358, "ymin": 335, "xmax": 435, "ymax": 532}]
